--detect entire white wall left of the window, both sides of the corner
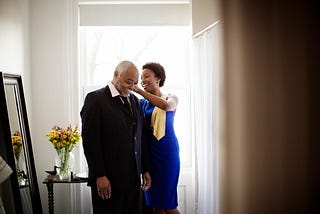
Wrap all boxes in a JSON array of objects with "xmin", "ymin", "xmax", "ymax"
[{"xmin": 0, "ymin": 0, "xmax": 76, "ymax": 213}]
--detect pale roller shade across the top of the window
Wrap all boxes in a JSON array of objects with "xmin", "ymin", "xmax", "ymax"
[{"xmin": 79, "ymin": 3, "xmax": 191, "ymax": 26}]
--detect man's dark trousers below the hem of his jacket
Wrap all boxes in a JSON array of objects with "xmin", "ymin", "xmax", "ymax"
[{"xmin": 91, "ymin": 185, "xmax": 141, "ymax": 214}]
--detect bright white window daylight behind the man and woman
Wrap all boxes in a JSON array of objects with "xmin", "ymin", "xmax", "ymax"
[{"xmin": 80, "ymin": 26, "xmax": 191, "ymax": 166}]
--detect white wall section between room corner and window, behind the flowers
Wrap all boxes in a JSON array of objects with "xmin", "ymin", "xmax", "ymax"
[{"xmin": 30, "ymin": 0, "xmax": 79, "ymax": 213}]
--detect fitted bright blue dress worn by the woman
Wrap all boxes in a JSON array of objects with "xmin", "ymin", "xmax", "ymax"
[{"xmin": 141, "ymin": 99, "xmax": 180, "ymax": 209}]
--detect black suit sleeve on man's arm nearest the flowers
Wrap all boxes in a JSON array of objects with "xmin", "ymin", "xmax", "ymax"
[{"xmin": 80, "ymin": 93, "xmax": 106, "ymax": 179}]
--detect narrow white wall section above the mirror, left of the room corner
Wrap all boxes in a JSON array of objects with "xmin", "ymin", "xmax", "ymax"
[{"xmin": 0, "ymin": 0, "xmax": 32, "ymax": 113}]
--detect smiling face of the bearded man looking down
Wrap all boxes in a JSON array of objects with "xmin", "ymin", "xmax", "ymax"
[{"xmin": 114, "ymin": 67, "xmax": 139, "ymax": 96}]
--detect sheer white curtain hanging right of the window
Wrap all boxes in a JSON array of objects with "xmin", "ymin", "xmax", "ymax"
[{"xmin": 194, "ymin": 23, "xmax": 221, "ymax": 214}]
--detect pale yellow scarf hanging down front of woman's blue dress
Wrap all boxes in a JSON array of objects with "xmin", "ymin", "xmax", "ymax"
[{"xmin": 151, "ymin": 95, "xmax": 166, "ymax": 140}]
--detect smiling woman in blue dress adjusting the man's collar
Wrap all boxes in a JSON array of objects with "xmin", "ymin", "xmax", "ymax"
[{"xmin": 134, "ymin": 62, "xmax": 180, "ymax": 214}]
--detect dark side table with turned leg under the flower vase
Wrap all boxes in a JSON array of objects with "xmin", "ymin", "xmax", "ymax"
[{"xmin": 42, "ymin": 177, "xmax": 88, "ymax": 214}]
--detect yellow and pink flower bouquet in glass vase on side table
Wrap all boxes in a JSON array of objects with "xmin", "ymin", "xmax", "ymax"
[{"xmin": 46, "ymin": 125, "xmax": 81, "ymax": 179}]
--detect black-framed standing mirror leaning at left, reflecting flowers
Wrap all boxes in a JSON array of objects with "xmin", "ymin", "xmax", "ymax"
[{"xmin": 0, "ymin": 72, "xmax": 42, "ymax": 214}]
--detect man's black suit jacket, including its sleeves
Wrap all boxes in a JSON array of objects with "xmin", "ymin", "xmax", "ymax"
[{"xmin": 80, "ymin": 86, "xmax": 148, "ymax": 192}]
